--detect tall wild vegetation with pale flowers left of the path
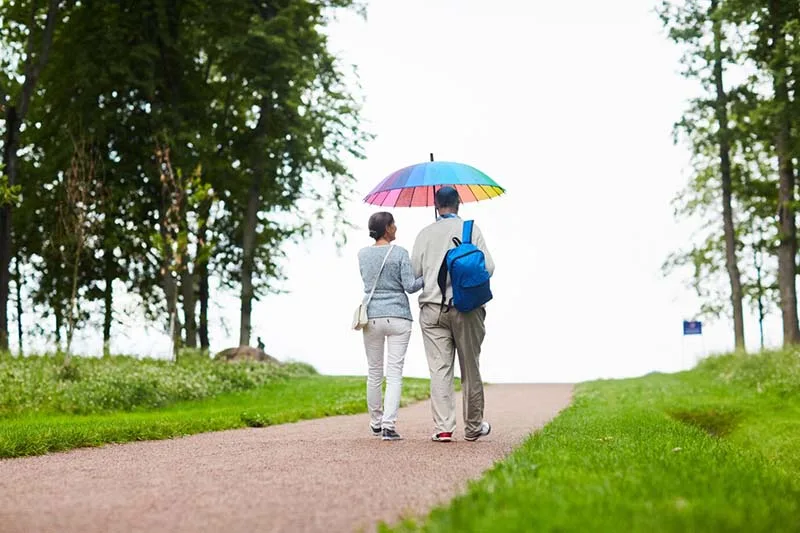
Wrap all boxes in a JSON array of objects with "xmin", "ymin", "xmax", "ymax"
[{"xmin": 0, "ymin": 356, "xmax": 316, "ymax": 416}]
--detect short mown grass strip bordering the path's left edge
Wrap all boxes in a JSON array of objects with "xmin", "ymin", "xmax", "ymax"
[{"xmin": 0, "ymin": 376, "xmax": 429, "ymax": 457}]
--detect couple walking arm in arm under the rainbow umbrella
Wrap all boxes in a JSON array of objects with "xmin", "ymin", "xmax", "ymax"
[{"xmin": 358, "ymin": 187, "xmax": 494, "ymax": 442}]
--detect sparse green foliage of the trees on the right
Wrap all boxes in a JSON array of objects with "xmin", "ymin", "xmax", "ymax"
[{"xmin": 658, "ymin": 0, "xmax": 800, "ymax": 332}]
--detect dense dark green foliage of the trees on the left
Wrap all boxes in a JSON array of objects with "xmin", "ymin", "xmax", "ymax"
[{"xmin": 0, "ymin": 0, "xmax": 371, "ymax": 350}]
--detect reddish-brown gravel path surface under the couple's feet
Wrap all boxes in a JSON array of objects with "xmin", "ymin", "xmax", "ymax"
[{"xmin": 0, "ymin": 385, "xmax": 572, "ymax": 533}]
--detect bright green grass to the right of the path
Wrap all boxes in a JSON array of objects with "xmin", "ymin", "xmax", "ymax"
[{"xmin": 390, "ymin": 352, "xmax": 800, "ymax": 533}]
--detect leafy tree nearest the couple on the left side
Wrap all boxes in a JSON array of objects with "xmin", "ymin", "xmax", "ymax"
[{"xmin": 200, "ymin": 0, "xmax": 368, "ymax": 345}]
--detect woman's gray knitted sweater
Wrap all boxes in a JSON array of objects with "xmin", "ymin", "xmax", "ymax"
[{"xmin": 358, "ymin": 246, "xmax": 422, "ymax": 320}]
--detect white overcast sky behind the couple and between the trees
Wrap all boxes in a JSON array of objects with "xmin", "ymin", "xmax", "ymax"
[{"xmin": 34, "ymin": 0, "xmax": 780, "ymax": 382}]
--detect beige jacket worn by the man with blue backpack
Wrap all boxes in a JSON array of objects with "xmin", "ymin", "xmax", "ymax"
[{"xmin": 411, "ymin": 217, "xmax": 494, "ymax": 306}]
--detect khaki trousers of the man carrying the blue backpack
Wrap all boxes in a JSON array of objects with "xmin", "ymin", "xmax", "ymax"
[{"xmin": 419, "ymin": 303, "xmax": 486, "ymax": 436}]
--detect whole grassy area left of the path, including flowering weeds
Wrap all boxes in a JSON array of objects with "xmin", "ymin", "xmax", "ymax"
[{"xmin": 0, "ymin": 356, "xmax": 438, "ymax": 458}]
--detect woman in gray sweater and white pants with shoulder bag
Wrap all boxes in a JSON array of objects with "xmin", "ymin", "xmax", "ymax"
[{"xmin": 358, "ymin": 212, "xmax": 422, "ymax": 440}]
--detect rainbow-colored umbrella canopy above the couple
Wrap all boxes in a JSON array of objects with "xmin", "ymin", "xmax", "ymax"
[{"xmin": 364, "ymin": 161, "xmax": 505, "ymax": 207}]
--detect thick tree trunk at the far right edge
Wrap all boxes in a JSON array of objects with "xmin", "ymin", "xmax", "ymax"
[{"xmin": 769, "ymin": 0, "xmax": 800, "ymax": 346}]
